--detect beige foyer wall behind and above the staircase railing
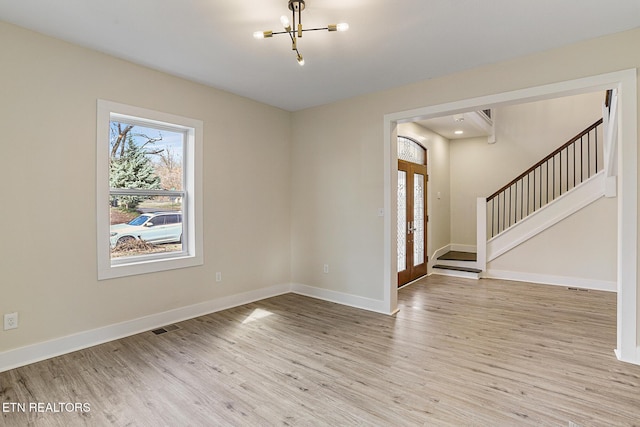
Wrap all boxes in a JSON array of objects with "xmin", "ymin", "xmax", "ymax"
[{"xmin": 451, "ymin": 91, "xmax": 604, "ymax": 246}]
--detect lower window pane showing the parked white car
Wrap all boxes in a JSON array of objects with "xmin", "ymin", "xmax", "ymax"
[{"xmin": 109, "ymin": 196, "xmax": 183, "ymax": 259}]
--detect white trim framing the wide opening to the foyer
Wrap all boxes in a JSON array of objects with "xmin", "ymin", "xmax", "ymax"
[{"xmin": 383, "ymin": 69, "xmax": 640, "ymax": 364}]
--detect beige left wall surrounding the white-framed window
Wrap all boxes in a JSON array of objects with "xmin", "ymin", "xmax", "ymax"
[{"xmin": 0, "ymin": 23, "xmax": 291, "ymax": 352}]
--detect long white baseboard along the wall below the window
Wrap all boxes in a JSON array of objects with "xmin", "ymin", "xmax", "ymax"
[{"xmin": 0, "ymin": 284, "xmax": 291, "ymax": 372}]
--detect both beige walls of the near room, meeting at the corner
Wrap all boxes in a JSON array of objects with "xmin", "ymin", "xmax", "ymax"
[{"xmin": 0, "ymin": 19, "xmax": 640, "ymax": 358}]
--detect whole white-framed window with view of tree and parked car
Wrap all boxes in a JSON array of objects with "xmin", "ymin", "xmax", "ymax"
[{"xmin": 97, "ymin": 100, "xmax": 203, "ymax": 279}]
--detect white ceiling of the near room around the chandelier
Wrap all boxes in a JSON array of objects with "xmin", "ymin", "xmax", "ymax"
[{"xmin": 0, "ymin": 0, "xmax": 640, "ymax": 111}]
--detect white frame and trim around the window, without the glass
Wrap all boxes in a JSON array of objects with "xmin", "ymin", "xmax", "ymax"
[{"xmin": 96, "ymin": 99, "xmax": 204, "ymax": 280}]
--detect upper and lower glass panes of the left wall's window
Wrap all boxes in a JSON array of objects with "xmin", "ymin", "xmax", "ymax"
[{"xmin": 109, "ymin": 120, "xmax": 185, "ymax": 259}]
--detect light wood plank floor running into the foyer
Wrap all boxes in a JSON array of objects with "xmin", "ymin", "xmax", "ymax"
[{"xmin": 0, "ymin": 276, "xmax": 640, "ymax": 427}]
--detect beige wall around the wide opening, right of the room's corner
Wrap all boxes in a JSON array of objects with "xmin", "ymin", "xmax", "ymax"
[{"xmin": 292, "ymin": 30, "xmax": 640, "ymax": 299}]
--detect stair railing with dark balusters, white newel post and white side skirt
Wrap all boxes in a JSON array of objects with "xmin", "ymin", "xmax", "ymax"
[{"xmin": 476, "ymin": 93, "xmax": 616, "ymax": 275}]
